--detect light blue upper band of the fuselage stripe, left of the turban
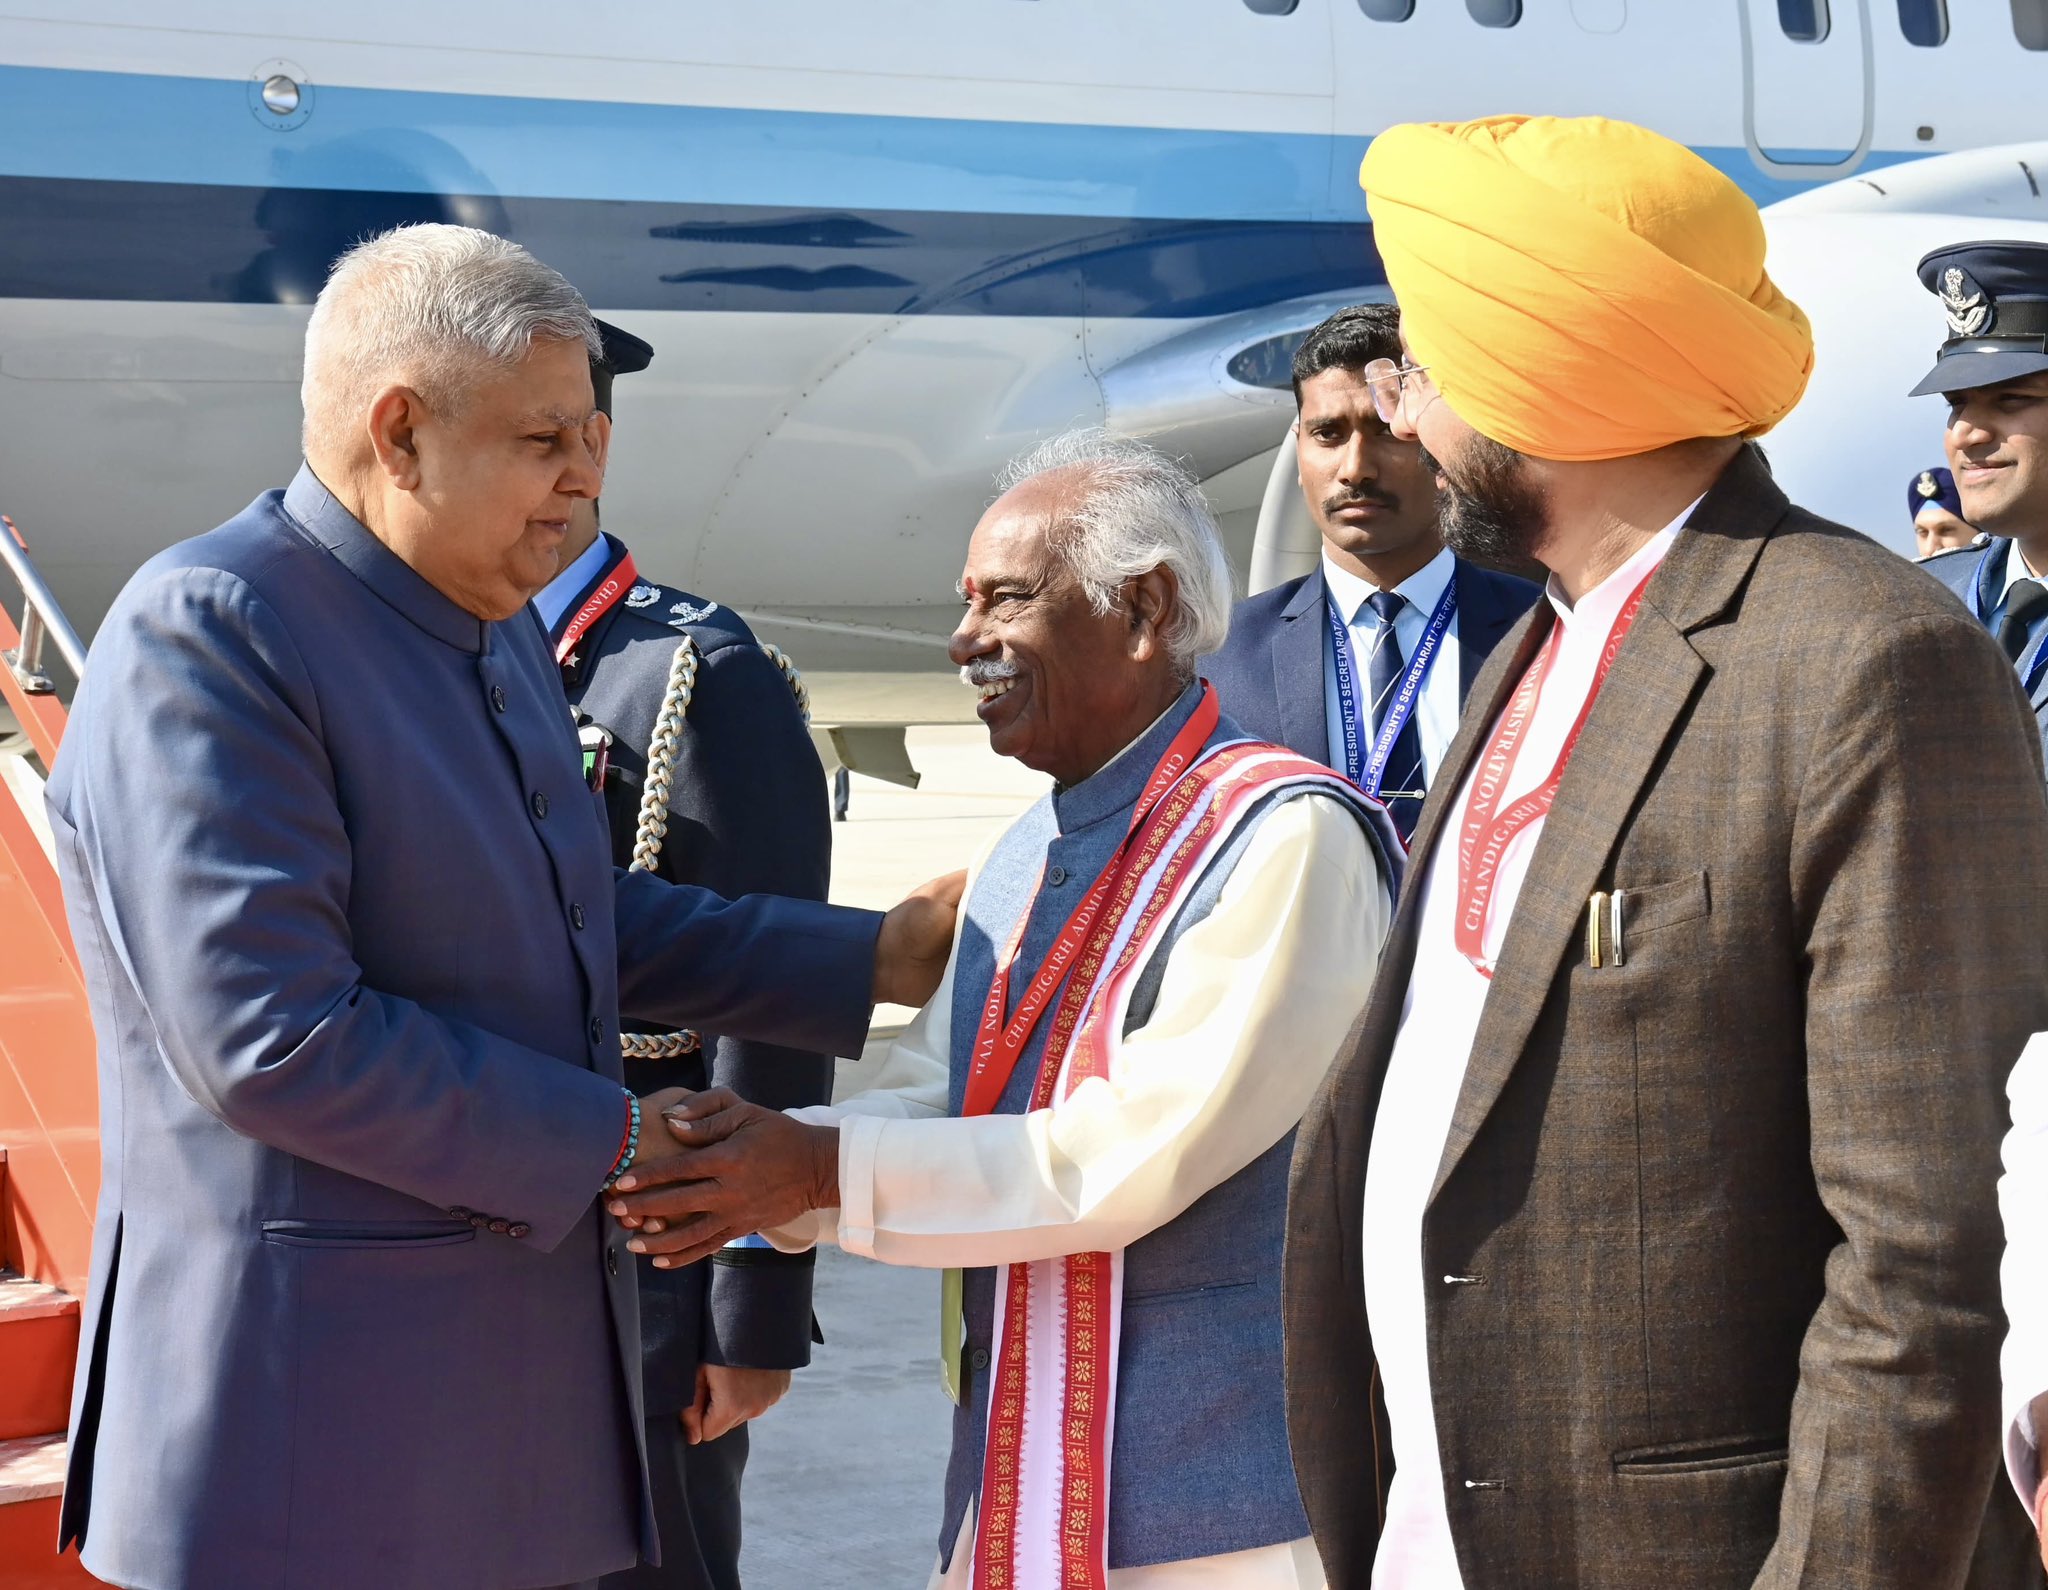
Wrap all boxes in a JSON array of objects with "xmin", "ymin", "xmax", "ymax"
[{"xmin": 0, "ymin": 66, "xmax": 1364, "ymax": 221}]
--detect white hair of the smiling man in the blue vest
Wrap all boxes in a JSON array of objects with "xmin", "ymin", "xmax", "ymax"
[{"xmin": 995, "ymin": 428, "xmax": 1231, "ymax": 678}]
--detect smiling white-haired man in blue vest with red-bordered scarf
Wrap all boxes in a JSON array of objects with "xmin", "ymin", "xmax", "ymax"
[{"xmin": 614, "ymin": 432, "xmax": 1401, "ymax": 1590}]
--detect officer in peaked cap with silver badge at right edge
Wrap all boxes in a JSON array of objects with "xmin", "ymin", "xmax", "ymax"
[{"xmin": 1913, "ymin": 242, "xmax": 2048, "ymax": 754}]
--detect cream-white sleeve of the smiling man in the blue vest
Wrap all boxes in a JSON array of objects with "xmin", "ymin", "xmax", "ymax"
[{"xmin": 838, "ymin": 795, "xmax": 1391, "ymax": 1268}]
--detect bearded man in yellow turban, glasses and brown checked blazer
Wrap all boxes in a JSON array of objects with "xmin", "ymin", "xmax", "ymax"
[{"xmin": 1286, "ymin": 117, "xmax": 2048, "ymax": 1590}]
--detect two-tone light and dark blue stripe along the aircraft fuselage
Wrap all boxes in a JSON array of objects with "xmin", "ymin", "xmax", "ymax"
[{"xmin": 0, "ymin": 66, "xmax": 1911, "ymax": 318}]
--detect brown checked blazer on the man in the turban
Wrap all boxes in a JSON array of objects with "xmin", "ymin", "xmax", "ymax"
[{"xmin": 1286, "ymin": 449, "xmax": 2048, "ymax": 1590}]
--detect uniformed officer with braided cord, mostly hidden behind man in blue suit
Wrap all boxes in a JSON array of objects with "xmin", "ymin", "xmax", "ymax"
[{"xmin": 535, "ymin": 320, "xmax": 831, "ymax": 1590}]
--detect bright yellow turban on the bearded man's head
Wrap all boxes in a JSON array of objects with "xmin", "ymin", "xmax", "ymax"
[{"xmin": 1358, "ymin": 117, "xmax": 1812, "ymax": 459}]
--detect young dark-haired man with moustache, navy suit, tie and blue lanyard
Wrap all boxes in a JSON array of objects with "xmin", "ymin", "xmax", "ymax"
[{"xmin": 1206, "ymin": 303, "xmax": 1538, "ymax": 840}]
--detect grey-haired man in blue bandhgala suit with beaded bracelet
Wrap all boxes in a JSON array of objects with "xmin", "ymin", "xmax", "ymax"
[{"xmin": 49, "ymin": 225, "xmax": 954, "ymax": 1590}]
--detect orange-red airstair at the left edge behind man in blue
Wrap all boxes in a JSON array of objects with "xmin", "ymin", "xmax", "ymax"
[{"xmin": 0, "ymin": 516, "xmax": 100, "ymax": 1590}]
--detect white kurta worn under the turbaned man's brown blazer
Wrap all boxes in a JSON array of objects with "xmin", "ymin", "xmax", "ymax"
[{"xmin": 1360, "ymin": 508, "xmax": 1692, "ymax": 1590}]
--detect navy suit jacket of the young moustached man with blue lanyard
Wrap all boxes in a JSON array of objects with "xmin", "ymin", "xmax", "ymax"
[{"xmin": 1202, "ymin": 557, "xmax": 1542, "ymax": 764}]
